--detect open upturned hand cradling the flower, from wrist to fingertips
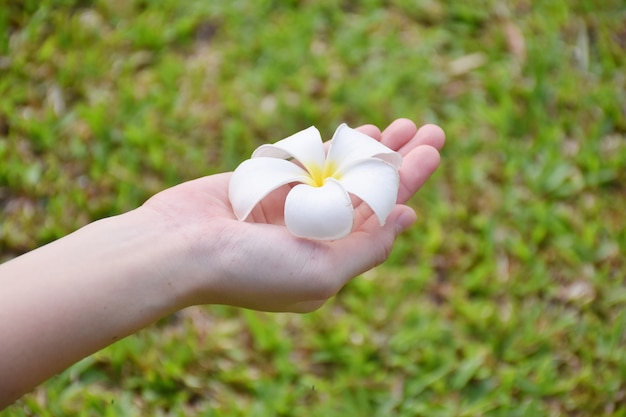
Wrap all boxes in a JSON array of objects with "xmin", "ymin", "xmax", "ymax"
[{"xmin": 139, "ymin": 119, "xmax": 445, "ymax": 312}]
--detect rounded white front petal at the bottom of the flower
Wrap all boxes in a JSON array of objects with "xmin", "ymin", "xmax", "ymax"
[{"xmin": 285, "ymin": 179, "xmax": 354, "ymax": 240}]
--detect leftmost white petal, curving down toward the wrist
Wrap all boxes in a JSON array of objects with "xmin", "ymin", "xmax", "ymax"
[{"xmin": 228, "ymin": 158, "xmax": 308, "ymax": 220}]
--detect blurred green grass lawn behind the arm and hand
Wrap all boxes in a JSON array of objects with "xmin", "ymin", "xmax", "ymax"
[{"xmin": 0, "ymin": 0, "xmax": 626, "ymax": 417}]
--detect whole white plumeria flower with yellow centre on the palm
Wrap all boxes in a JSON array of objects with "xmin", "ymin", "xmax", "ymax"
[{"xmin": 229, "ymin": 124, "xmax": 402, "ymax": 240}]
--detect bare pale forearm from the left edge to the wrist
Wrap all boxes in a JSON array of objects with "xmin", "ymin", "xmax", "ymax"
[{"xmin": 0, "ymin": 208, "xmax": 186, "ymax": 409}]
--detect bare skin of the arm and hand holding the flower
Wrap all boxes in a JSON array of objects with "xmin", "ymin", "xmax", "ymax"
[{"xmin": 0, "ymin": 119, "xmax": 445, "ymax": 410}]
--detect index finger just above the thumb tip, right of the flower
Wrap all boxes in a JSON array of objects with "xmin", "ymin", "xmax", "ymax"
[{"xmin": 397, "ymin": 145, "xmax": 440, "ymax": 204}]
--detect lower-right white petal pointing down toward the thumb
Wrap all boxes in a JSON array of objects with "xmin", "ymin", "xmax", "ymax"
[{"xmin": 339, "ymin": 158, "xmax": 400, "ymax": 226}]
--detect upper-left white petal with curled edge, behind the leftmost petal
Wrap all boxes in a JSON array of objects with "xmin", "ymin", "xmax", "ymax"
[{"xmin": 252, "ymin": 126, "xmax": 326, "ymax": 173}]
